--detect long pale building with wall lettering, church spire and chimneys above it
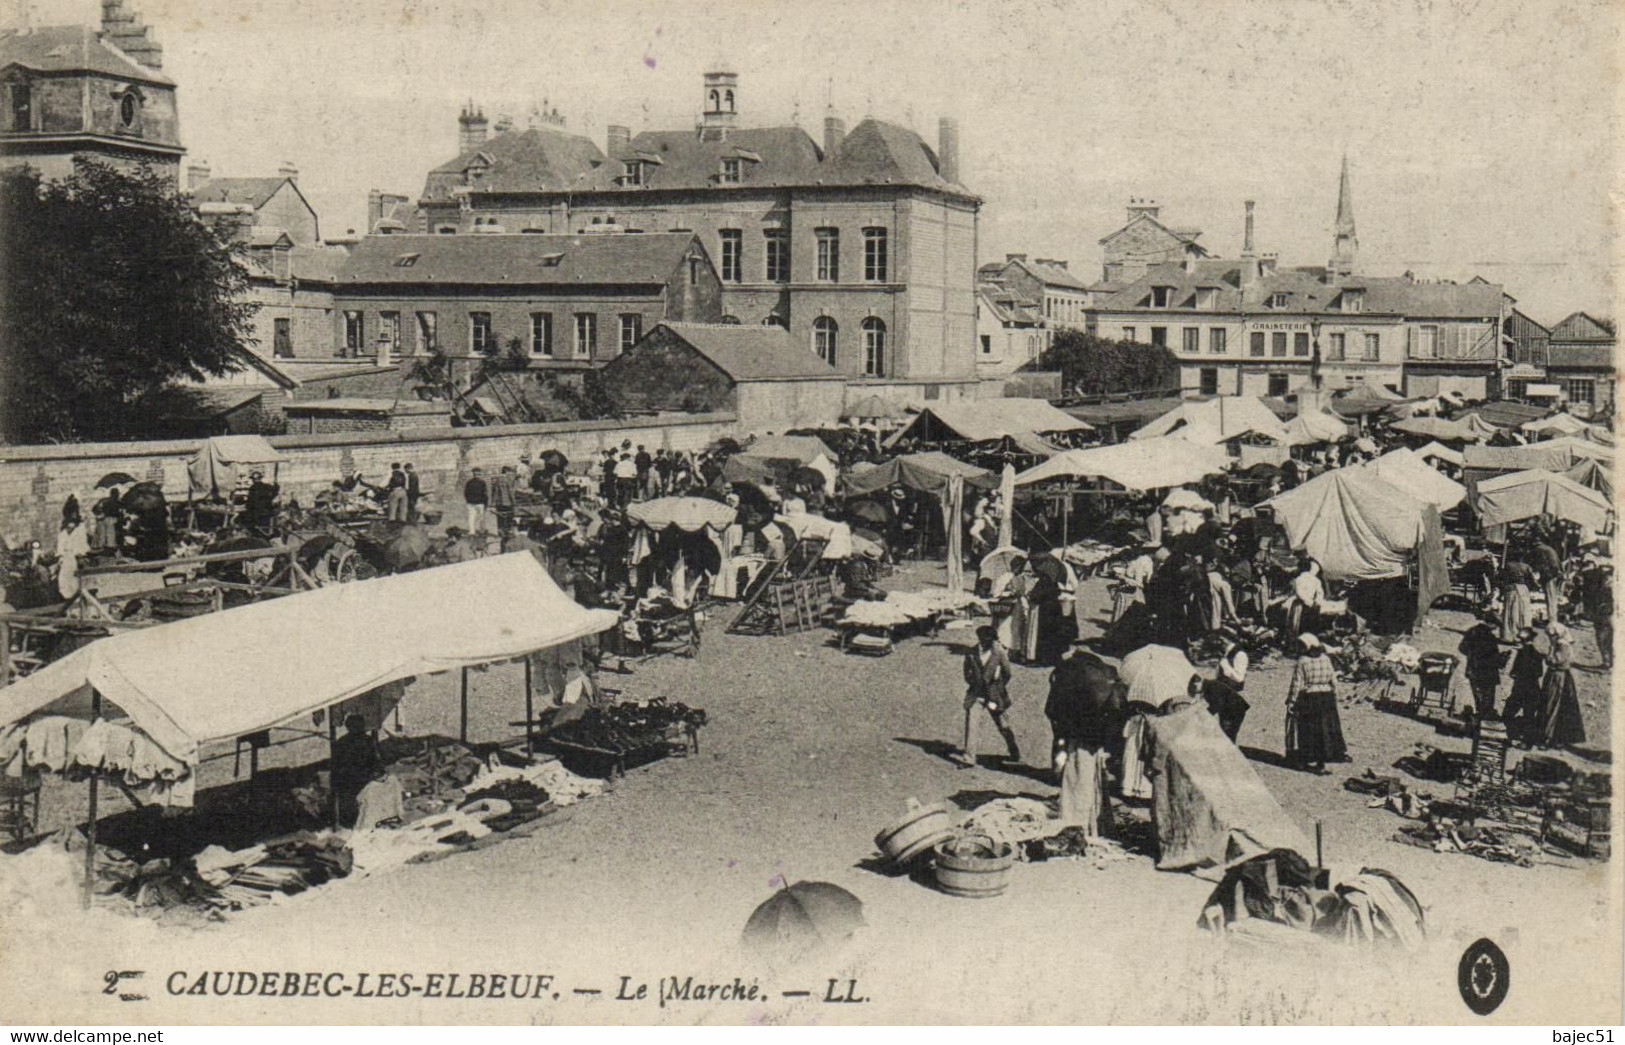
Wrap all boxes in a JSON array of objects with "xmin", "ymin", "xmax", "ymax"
[{"xmin": 1090, "ymin": 163, "xmax": 1506, "ymax": 398}]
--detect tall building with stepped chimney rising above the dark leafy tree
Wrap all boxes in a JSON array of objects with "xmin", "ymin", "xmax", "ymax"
[{"xmin": 0, "ymin": 0, "xmax": 185, "ymax": 184}]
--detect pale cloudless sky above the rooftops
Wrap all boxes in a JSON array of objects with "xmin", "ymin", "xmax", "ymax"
[{"xmin": 12, "ymin": 0, "xmax": 1625, "ymax": 323}]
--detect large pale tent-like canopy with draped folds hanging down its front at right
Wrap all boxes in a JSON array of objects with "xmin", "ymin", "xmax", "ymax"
[{"xmin": 1264, "ymin": 468, "xmax": 1427, "ymax": 580}]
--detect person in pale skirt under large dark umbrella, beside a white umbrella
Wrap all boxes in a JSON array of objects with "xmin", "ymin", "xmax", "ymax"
[{"xmin": 1043, "ymin": 647, "xmax": 1128, "ymax": 837}]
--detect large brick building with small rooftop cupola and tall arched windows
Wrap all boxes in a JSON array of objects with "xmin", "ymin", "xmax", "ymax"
[{"xmin": 401, "ymin": 72, "xmax": 982, "ymax": 403}]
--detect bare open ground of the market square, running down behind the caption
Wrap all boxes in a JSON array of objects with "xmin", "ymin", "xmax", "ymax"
[{"xmin": 0, "ymin": 567, "xmax": 1620, "ymax": 1025}]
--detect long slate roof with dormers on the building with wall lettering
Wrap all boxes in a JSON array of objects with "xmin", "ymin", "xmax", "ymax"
[{"xmin": 1097, "ymin": 258, "xmax": 1502, "ymax": 319}]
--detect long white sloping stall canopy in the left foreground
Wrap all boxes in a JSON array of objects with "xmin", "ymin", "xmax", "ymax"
[{"xmin": 0, "ymin": 553, "xmax": 619, "ymax": 765}]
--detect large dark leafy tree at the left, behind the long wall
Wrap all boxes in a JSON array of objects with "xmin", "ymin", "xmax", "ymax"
[{"xmin": 0, "ymin": 161, "xmax": 258, "ymax": 442}]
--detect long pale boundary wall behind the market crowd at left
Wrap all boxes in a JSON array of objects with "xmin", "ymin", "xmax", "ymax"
[{"xmin": 0, "ymin": 414, "xmax": 739, "ymax": 548}]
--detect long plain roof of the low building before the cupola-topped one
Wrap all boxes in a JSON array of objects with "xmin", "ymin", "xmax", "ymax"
[{"xmin": 336, "ymin": 232, "xmax": 694, "ymax": 286}]
